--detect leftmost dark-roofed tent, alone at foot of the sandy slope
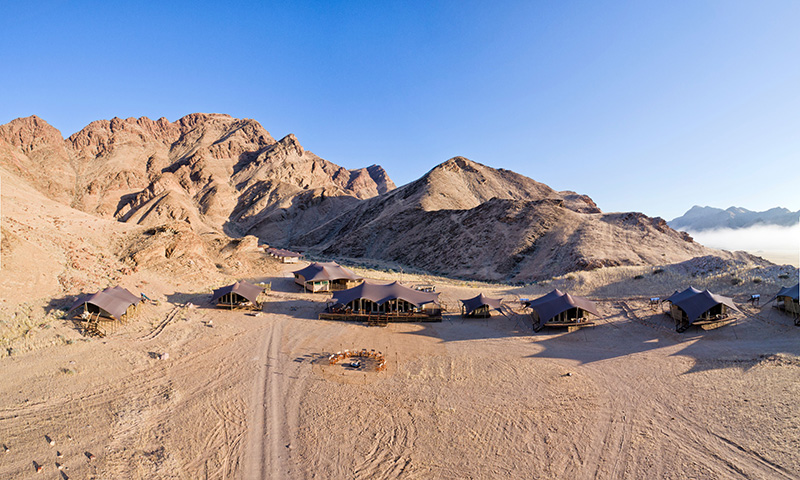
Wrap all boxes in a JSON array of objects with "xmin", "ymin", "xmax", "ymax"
[{"xmin": 67, "ymin": 286, "xmax": 141, "ymax": 336}]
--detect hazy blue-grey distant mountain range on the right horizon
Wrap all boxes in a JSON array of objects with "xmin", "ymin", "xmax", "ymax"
[{"xmin": 669, "ymin": 205, "xmax": 800, "ymax": 232}]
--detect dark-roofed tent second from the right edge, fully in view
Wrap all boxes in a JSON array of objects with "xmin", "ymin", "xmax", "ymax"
[{"xmin": 665, "ymin": 287, "xmax": 739, "ymax": 333}]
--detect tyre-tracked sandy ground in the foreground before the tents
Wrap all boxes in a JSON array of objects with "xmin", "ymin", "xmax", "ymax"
[{"xmin": 0, "ymin": 267, "xmax": 800, "ymax": 479}]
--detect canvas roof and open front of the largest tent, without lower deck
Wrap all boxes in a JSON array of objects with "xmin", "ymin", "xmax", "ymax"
[{"xmin": 332, "ymin": 282, "xmax": 441, "ymax": 314}]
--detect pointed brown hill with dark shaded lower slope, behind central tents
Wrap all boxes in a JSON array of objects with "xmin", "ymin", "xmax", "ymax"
[{"xmin": 295, "ymin": 157, "xmax": 730, "ymax": 281}]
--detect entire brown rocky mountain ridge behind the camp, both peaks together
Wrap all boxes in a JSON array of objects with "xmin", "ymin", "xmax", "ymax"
[{"xmin": 0, "ymin": 113, "xmax": 764, "ymax": 281}]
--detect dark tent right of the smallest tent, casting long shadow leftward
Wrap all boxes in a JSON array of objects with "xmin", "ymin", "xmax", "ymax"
[{"xmin": 526, "ymin": 289, "xmax": 600, "ymax": 332}]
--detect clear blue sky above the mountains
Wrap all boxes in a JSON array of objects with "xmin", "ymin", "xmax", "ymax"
[{"xmin": 0, "ymin": 0, "xmax": 800, "ymax": 219}]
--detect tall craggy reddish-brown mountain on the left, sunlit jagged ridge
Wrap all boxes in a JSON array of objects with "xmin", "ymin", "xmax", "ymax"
[{"xmin": 0, "ymin": 113, "xmax": 394, "ymax": 239}]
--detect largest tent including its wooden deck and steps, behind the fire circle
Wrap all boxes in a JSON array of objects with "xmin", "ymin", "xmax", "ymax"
[{"xmin": 320, "ymin": 282, "xmax": 442, "ymax": 322}]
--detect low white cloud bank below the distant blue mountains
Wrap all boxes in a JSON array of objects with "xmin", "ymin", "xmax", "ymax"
[{"xmin": 689, "ymin": 224, "xmax": 800, "ymax": 266}]
